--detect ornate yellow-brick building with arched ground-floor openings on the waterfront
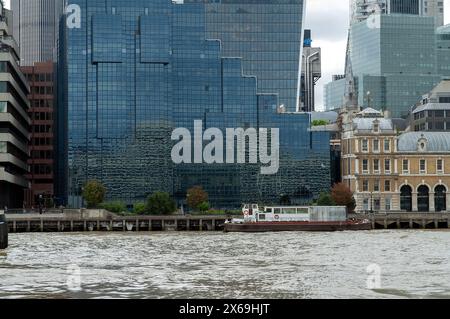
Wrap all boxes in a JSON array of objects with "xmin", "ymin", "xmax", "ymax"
[{"xmin": 341, "ymin": 109, "xmax": 450, "ymax": 212}]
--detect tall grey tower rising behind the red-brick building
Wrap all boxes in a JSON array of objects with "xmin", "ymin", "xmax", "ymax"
[{"xmin": 11, "ymin": 0, "xmax": 64, "ymax": 66}]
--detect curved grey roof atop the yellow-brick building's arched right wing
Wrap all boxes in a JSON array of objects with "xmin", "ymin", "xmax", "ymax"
[{"xmin": 398, "ymin": 132, "xmax": 450, "ymax": 153}]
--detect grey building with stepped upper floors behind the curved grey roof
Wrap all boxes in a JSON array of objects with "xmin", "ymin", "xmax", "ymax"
[{"xmin": 411, "ymin": 80, "xmax": 450, "ymax": 132}]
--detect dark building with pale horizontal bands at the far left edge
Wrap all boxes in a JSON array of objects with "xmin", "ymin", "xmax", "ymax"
[{"xmin": 0, "ymin": 5, "xmax": 30, "ymax": 208}]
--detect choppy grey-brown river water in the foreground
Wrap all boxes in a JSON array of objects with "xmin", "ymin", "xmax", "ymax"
[{"xmin": 0, "ymin": 230, "xmax": 450, "ymax": 299}]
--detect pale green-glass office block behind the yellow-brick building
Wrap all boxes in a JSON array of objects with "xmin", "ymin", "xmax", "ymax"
[{"xmin": 325, "ymin": 14, "xmax": 450, "ymax": 118}]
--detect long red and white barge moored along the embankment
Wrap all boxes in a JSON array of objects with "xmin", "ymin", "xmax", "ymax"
[{"xmin": 224, "ymin": 204, "xmax": 372, "ymax": 233}]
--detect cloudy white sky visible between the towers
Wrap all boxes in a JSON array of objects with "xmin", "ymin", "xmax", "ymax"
[{"xmin": 6, "ymin": 0, "xmax": 450, "ymax": 111}]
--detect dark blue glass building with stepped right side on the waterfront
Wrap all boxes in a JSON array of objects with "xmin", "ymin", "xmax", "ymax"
[{"xmin": 59, "ymin": 0, "xmax": 330, "ymax": 207}]
